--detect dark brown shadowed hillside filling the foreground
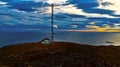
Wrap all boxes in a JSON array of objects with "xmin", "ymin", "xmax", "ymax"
[{"xmin": 0, "ymin": 42, "xmax": 120, "ymax": 67}]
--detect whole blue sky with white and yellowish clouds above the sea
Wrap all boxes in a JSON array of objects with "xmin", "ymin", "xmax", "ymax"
[{"xmin": 0, "ymin": 0, "xmax": 120, "ymax": 31}]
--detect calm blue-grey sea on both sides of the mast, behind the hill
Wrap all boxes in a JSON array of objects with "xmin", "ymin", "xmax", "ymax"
[{"xmin": 0, "ymin": 32, "xmax": 120, "ymax": 47}]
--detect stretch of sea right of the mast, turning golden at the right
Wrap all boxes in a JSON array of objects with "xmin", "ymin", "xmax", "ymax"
[{"xmin": 56, "ymin": 32, "xmax": 120, "ymax": 46}]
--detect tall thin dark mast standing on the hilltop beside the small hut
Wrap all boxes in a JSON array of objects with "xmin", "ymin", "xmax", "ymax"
[{"xmin": 51, "ymin": 3, "xmax": 54, "ymax": 42}]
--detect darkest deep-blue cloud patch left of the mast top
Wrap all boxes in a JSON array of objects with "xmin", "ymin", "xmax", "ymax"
[{"xmin": 10, "ymin": 1, "xmax": 47, "ymax": 12}]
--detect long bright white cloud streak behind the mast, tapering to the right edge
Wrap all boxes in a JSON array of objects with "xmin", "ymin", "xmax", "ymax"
[{"xmin": 41, "ymin": 4, "xmax": 118, "ymax": 18}]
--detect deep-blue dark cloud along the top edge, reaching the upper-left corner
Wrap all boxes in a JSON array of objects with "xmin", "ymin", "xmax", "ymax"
[{"xmin": 2, "ymin": 0, "xmax": 48, "ymax": 12}]
